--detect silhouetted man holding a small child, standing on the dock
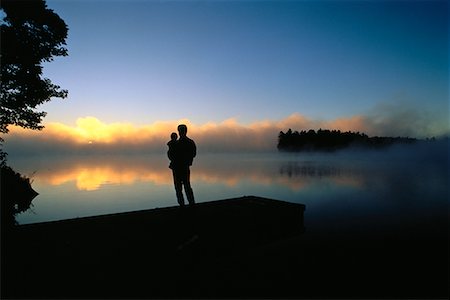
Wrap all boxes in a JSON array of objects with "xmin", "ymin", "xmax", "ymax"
[{"xmin": 170, "ymin": 124, "xmax": 197, "ymax": 206}]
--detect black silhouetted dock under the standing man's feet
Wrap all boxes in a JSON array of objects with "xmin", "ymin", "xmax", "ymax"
[{"xmin": 2, "ymin": 196, "xmax": 305, "ymax": 298}]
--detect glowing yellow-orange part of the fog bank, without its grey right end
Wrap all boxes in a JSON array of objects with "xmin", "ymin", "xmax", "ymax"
[{"xmin": 5, "ymin": 113, "xmax": 376, "ymax": 153}]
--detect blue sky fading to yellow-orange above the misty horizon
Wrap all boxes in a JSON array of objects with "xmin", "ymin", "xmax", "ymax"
[{"xmin": 4, "ymin": 0, "xmax": 450, "ymax": 154}]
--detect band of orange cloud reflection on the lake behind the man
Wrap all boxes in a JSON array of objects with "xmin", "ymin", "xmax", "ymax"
[{"xmin": 21, "ymin": 155, "xmax": 362, "ymax": 191}]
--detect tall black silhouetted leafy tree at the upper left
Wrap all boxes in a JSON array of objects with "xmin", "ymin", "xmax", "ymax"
[{"xmin": 0, "ymin": 0, "xmax": 68, "ymax": 162}]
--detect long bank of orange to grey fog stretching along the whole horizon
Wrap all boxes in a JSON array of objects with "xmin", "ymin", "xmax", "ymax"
[{"xmin": 5, "ymin": 105, "xmax": 446, "ymax": 154}]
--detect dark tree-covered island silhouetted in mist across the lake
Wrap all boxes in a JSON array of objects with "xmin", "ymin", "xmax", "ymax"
[{"xmin": 277, "ymin": 129, "xmax": 417, "ymax": 151}]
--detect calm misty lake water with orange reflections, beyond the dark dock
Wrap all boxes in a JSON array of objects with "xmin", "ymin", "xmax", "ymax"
[{"xmin": 9, "ymin": 144, "xmax": 449, "ymax": 236}]
